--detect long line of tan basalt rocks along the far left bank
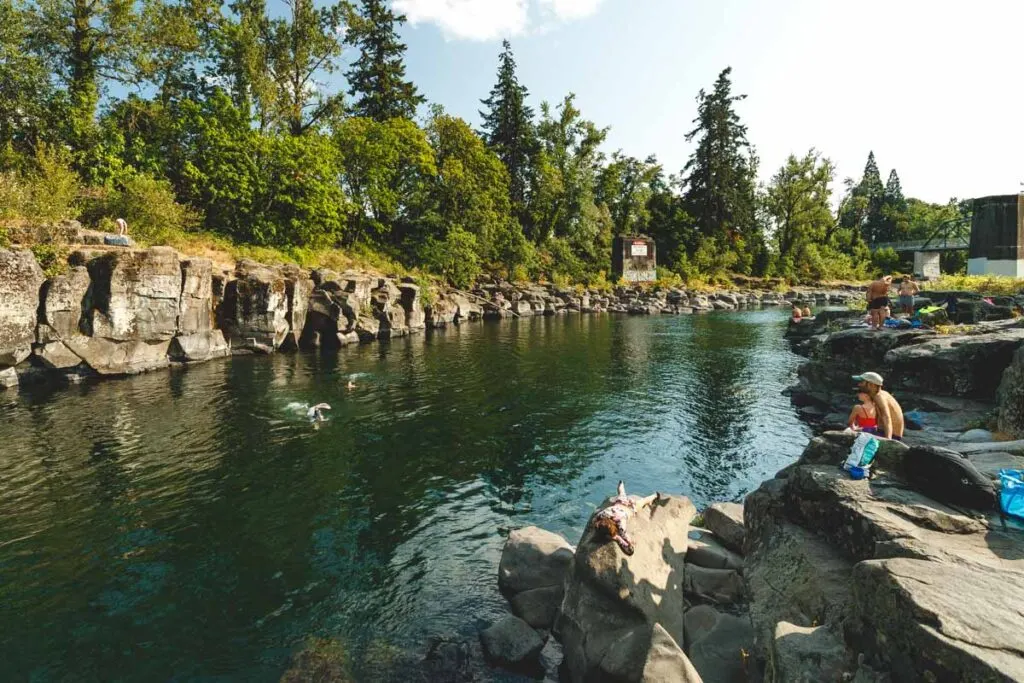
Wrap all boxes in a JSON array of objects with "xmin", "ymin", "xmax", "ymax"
[{"xmin": 0, "ymin": 246, "xmax": 855, "ymax": 395}]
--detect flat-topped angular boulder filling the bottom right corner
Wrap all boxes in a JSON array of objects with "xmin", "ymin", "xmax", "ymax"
[{"xmin": 853, "ymin": 558, "xmax": 1024, "ymax": 681}]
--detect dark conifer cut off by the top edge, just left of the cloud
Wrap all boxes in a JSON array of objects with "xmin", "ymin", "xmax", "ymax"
[{"xmin": 345, "ymin": 0, "xmax": 425, "ymax": 121}]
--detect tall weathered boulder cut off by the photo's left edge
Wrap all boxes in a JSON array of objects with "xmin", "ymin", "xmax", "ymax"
[{"xmin": 0, "ymin": 249, "xmax": 44, "ymax": 368}]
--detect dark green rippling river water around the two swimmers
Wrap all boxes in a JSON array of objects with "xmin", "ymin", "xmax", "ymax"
[{"xmin": 0, "ymin": 310, "xmax": 809, "ymax": 681}]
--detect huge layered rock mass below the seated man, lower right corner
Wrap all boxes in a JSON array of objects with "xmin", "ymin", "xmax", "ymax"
[{"xmin": 744, "ymin": 433, "xmax": 1024, "ymax": 681}]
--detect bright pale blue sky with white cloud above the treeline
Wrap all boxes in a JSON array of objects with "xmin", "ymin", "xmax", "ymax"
[{"xmin": 385, "ymin": 0, "xmax": 1024, "ymax": 202}]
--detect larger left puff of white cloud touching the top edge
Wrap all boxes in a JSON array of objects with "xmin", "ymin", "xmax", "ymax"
[{"xmin": 394, "ymin": 0, "xmax": 528, "ymax": 40}]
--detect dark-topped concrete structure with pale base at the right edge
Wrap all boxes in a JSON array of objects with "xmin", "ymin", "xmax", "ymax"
[{"xmin": 967, "ymin": 193, "xmax": 1024, "ymax": 278}]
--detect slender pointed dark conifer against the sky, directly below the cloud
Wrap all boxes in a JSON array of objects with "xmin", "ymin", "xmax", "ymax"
[{"xmin": 480, "ymin": 40, "xmax": 537, "ymax": 235}]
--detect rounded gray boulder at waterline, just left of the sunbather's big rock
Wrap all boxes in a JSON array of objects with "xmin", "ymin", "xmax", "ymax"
[{"xmin": 498, "ymin": 526, "xmax": 572, "ymax": 595}]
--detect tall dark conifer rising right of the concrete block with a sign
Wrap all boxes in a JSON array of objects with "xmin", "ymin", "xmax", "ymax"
[{"xmin": 683, "ymin": 68, "xmax": 758, "ymax": 266}]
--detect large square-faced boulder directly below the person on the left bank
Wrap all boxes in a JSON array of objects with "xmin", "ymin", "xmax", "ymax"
[{"xmin": 84, "ymin": 247, "xmax": 181, "ymax": 344}]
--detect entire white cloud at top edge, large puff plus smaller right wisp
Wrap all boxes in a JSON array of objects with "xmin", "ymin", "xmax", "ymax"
[{"xmin": 393, "ymin": 0, "xmax": 602, "ymax": 40}]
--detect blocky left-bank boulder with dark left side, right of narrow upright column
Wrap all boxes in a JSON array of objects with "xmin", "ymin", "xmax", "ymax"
[{"xmin": 220, "ymin": 259, "xmax": 289, "ymax": 353}]
